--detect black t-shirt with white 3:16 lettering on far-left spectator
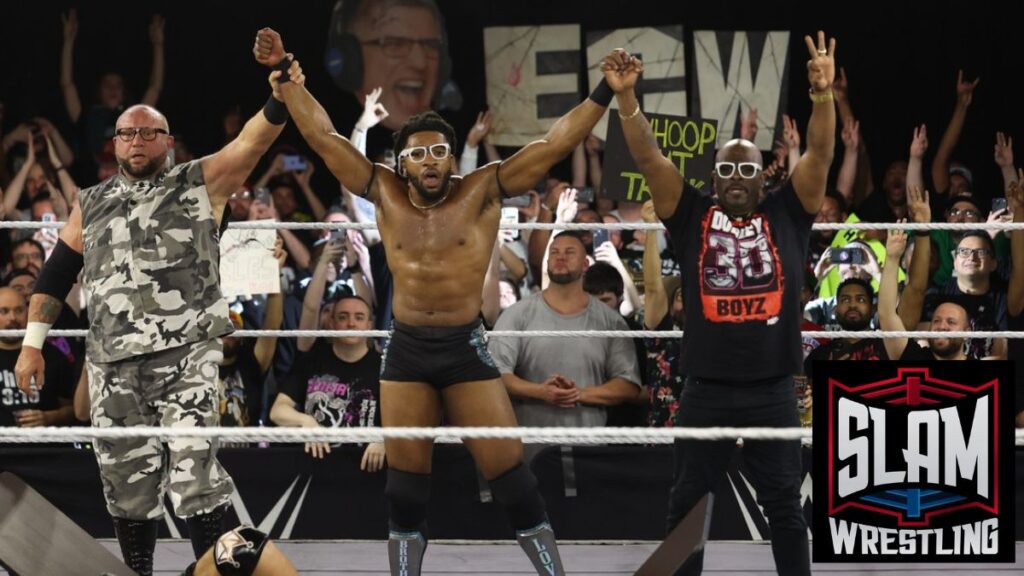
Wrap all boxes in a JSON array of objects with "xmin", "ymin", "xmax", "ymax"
[{"xmin": 0, "ymin": 344, "xmax": 78, "ymax": 426}]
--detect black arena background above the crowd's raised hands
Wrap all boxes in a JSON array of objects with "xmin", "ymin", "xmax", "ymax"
[{"xmin": 0, "ymin": 0, "xmax": 1024, "ymax": 201}]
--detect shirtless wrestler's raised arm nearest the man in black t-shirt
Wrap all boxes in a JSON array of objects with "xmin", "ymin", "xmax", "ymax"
[{"xmin": 488, "ymin": 49, "xmax": 630, "ymax": 196}]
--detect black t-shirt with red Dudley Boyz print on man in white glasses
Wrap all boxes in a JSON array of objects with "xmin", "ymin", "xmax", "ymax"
[{"xmin": 665, "ymin": 177, "xmax": 814, "ymax": 380}]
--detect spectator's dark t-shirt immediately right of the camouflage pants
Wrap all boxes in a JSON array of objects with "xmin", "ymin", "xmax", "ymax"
[{"xmin": 217, "ymin": 338, "xmax": 266, "ymax": 426}]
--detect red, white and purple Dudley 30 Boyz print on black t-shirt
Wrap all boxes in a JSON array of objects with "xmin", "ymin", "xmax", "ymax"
[{"xmin": 697, "ymin": 206, "xmax": 784, "ymax": 322}]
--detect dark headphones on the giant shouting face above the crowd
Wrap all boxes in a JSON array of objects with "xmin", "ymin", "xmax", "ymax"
[{"xmin": 324, "ymin": 0, "xmax": 462, "ymax": 110}]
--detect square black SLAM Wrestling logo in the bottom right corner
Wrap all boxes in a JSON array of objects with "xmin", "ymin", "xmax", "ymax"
[{"xmin": 814, "ymin": 362, "xmax": 1014, "ymax": 563}]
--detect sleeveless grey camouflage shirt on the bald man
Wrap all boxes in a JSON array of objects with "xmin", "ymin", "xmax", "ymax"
[{"xmin": 79, "ymin": 161, "xmax": 232, "ymax": 362}]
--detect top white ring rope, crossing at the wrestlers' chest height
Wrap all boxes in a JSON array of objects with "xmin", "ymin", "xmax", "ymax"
[{"xmin": 6, "ymin": 220, "xmax": 1024, "ymax": 231}]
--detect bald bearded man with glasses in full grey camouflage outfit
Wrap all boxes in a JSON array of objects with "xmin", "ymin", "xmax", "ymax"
[{"xmin": 15, "ymin": 60, "xmax": 302, "ymax": 574}]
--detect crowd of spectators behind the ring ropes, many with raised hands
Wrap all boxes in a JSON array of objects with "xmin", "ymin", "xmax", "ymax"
[{"xmin": 0, "ymin": 10, "xmax": 1024, "ymax": 471}]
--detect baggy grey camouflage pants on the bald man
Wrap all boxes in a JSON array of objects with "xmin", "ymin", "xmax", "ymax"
[{"xmin": 87, "ymin": 339, "xmax": 234, "ymax": 520}]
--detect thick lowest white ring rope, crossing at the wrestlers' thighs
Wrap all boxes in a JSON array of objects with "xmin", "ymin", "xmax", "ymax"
[{"xmin": 0, "ymin": 426, "xmax": 1024, "ymax": 445}]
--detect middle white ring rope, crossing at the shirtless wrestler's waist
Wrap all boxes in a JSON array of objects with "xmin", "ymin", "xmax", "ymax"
[{"xmin": 0, "ymin": 330, "xmax": 1024, "ymax": 339}]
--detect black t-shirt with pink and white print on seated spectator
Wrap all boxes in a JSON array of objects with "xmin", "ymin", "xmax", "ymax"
[{"xmin": 281, "ymin": 338, "xmax": 381, "ymax": 427}]
